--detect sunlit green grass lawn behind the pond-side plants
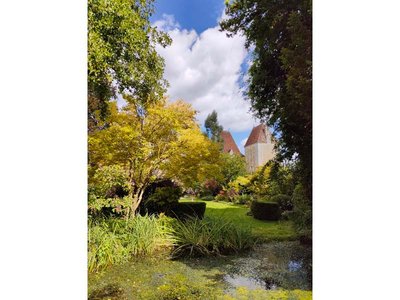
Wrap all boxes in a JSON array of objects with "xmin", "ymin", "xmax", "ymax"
[{"xmin": 181, "ymin": 198, "xmax": 297, "ymax": 241}]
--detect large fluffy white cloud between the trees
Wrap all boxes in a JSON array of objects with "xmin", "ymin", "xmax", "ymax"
[{"xmin": 154, "ymin": 15, "xmax": 255, "ymax": 131}]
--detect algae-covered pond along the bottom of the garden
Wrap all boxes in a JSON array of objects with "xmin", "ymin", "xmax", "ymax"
[{"xmin": 89, "ymin": 242, "xmax": 312, "ymax": 299}]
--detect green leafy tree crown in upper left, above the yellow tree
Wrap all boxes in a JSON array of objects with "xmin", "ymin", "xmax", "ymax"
[{"xmin": 88, "ymin": 0, "xmax": 171, "ymax": 130}]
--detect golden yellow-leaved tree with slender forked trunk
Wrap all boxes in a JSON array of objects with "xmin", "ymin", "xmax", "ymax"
[{"xmin": 88, "ymin": 99, "xmax": 220, "ymax": 217}]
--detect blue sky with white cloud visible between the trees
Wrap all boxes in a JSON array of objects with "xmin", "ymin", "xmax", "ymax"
[{"xmin": 151, "ymin": 0, "xmax": 258, "ymax": 153}]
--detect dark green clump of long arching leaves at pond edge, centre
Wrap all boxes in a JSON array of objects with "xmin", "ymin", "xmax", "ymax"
[{"xmin": 173, "ymin": 217, "xmax": 255, "ymax": 256}]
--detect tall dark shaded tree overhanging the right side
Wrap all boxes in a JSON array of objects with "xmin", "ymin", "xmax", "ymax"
[{"xmin": 220, "ymin": 0, "xmax": 312, "ymax": 201}]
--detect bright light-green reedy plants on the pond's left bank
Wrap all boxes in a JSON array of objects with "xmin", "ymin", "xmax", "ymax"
[{"xmin": 88, "ymin": 215, "xmax": 174, "ymax": 272}]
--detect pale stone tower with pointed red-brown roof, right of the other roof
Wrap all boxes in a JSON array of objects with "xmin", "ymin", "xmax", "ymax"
[{"xmin": 244, "ymin": 124, "xmax": 275, "ymax": 173}]
